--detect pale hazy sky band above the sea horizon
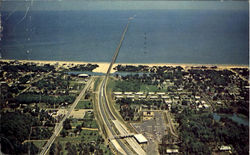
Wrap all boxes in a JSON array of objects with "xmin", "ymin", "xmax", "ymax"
[{"xmin": 1, "ymin": 1, "xmax": 248, "ymax": 11}]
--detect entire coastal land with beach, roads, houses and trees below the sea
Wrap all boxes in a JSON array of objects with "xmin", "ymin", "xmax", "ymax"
[{"xmin": 0, "ymin": 59, "xmax": 249, "ymax": 155}]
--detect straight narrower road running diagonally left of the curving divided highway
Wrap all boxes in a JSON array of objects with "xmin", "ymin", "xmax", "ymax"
[{"xmin": 40, "ymin": 78, "xmax": 93, "ymax": 155}]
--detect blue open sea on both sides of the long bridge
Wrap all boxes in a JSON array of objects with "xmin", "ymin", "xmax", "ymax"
[{"xmin": 0, "ymin": 1, "xmax": 249, "ymax": 64}]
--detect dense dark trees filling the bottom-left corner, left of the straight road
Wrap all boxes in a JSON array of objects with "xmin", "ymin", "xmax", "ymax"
[{"xmin": 0, "ymin": 111, "xmax": 43, "ymax": 154}]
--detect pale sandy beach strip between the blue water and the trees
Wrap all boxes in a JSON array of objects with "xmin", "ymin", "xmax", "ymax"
[{"xmin": 0, "ymin": 59, "xmax": 249, "ymax": 73}]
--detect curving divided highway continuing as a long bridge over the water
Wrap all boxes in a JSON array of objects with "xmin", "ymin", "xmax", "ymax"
[{"xmin": 98, "ymin": 18, "xmax": 146, "ymax": 155}]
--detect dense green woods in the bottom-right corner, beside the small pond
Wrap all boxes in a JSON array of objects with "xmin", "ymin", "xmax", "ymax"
[{"xmin": 176, "ymin": 108, "xmax": 249, "ymax": 154}]
